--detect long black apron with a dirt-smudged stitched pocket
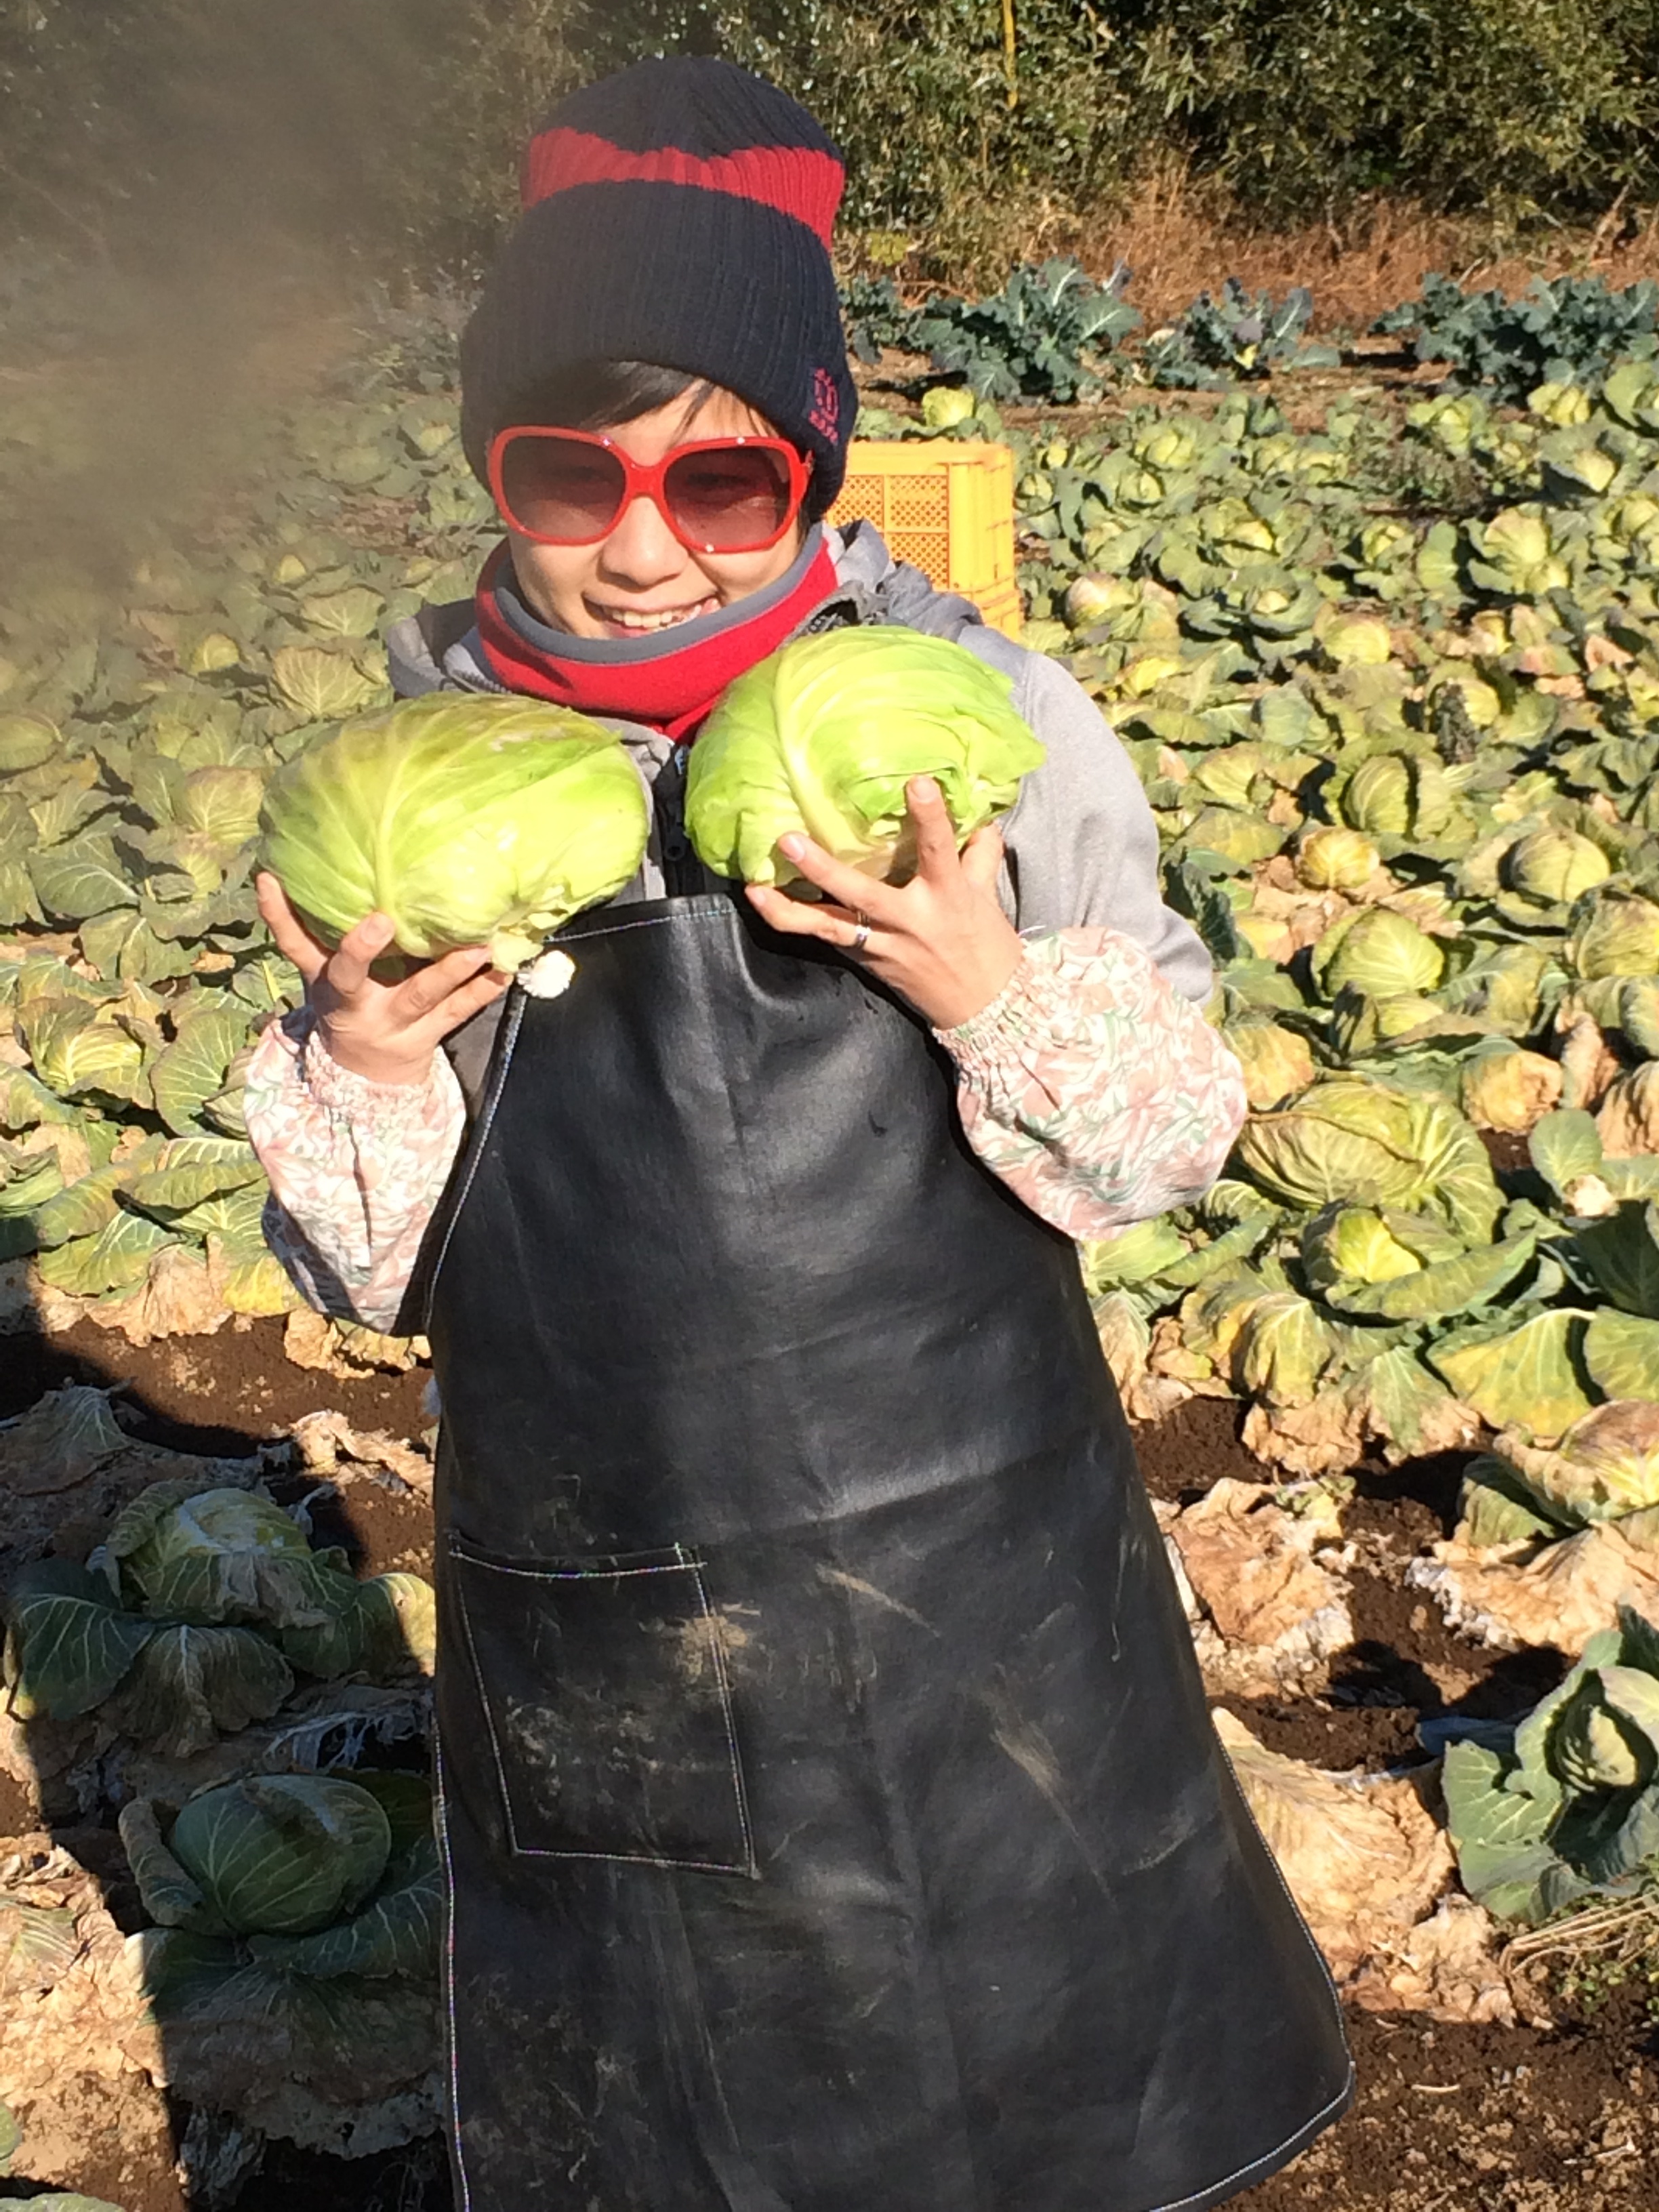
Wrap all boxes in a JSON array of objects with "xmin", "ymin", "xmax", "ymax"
[{"xmin": 429, "ymin": 894, "xmax": 1349, "ymax": 2212}]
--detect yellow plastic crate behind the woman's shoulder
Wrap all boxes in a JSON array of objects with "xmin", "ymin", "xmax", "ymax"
[{"xmin": 830, "ymin": 438, "xmax": 1024, "ymax": 637}]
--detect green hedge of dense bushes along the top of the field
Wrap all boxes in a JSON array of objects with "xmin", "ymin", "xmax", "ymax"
[{"xmin": 0, "ymin": 0, "xmax": 1659, "ymax": 285}]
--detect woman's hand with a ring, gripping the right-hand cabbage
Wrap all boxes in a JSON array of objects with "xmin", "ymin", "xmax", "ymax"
[{"xmin": 747, "ymin": 777, "xmax": 1024, "ymax": 1029}]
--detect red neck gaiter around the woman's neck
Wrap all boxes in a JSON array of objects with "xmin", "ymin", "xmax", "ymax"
[{"xmin": 476, "ymin": 544, "xmax": 836, "ymax": 739}]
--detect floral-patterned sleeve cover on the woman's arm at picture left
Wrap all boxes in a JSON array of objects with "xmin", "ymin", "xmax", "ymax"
[{"xmin": 245, "ymin": 1011, "xmax": 467, "ymax": 1330}]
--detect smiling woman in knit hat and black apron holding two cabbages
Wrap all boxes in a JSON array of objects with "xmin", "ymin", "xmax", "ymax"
[{"xmin": 250, "ymin": 60, "xmax": 1349, "ymax": 2212}]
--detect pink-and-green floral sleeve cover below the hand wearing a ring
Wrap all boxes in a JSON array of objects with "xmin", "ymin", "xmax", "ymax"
[{"xmin": 936, "ymin": 929, "xmax": 1246, "ymax": 1239}]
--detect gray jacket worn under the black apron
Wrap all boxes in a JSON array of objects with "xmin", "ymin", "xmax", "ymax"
[{"xmin": 387, "ymin": 522, "xmax": 1210, "ymax": 1000}]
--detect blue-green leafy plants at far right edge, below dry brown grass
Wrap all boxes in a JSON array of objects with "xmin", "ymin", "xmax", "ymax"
[{"xmin": 1372, "ymin": 274, "xmax": 1659, "ymax": 405}]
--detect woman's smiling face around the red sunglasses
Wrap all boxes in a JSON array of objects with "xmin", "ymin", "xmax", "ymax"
[{"xmin": 506, "ymin": 389, "xmax": 805, "ymax": 637}]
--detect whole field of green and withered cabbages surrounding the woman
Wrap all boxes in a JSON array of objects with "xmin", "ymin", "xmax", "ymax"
[{"xmin": 0, "ymin": 301, "xmax": 1659, "ymax": 2212}]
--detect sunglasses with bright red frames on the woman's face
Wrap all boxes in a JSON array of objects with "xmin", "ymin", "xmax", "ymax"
[{"xmin": 489, "ymin": 425, "xmax": 812, "ymax": 553}]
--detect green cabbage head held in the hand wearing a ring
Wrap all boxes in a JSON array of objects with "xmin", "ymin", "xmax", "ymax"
[{"xmin": 686, "ymin": 628, "xmax": 1044, "ymax": 882}]
